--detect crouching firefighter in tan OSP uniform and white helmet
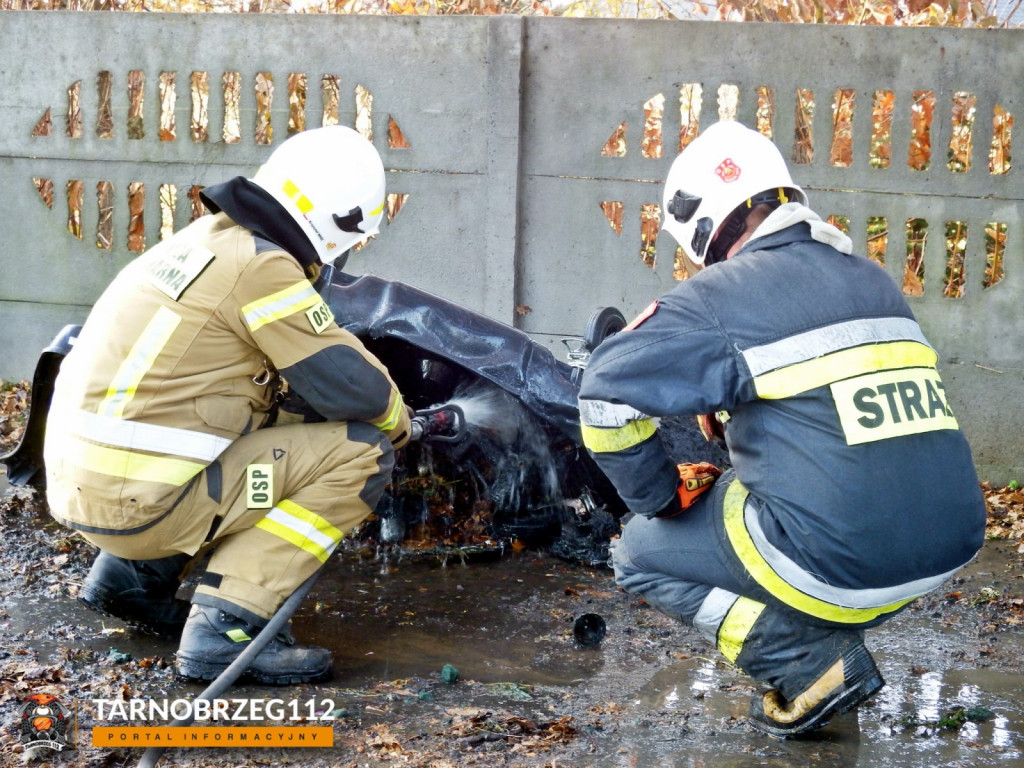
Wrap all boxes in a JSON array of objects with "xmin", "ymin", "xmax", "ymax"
[{"xmin": 45, "ymin": 126, "xmax": 410, "ymax": 684}]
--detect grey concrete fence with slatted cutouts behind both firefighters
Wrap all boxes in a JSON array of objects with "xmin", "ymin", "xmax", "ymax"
[{"xmin": 0, "ymin": 11, "xmax": 1024, "ymax": 482}]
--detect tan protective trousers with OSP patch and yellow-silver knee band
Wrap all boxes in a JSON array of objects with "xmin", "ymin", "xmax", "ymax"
[{"xmin": 77, "ymin": 422, "xmax": 394, "ymax": 624}]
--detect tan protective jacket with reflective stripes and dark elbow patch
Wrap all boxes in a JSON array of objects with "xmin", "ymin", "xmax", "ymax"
[{"xmin": 45, "ymin": 213, "xmax": 410, "ymax": 534}]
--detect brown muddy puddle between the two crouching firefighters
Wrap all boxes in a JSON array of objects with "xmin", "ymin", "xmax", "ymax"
[{"xmin": 294, "ymin": 554, "xmax": 608, "ymax": 685}]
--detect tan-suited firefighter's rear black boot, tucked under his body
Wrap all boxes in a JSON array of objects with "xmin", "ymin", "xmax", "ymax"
[{"xmin": 78, "ymin": 551, "xmax": 191, "ymax": 637}]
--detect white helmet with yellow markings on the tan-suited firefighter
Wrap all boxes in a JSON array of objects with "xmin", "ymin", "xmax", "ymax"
[{"xmin": 252, "ymin": 125, "xmax": 384, "ymax": 264}]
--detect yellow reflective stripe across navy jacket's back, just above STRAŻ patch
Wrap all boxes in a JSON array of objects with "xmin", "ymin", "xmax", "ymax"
[{"xmin": 754, "ymin": 341, "xmax": 938, "ymax": 400}]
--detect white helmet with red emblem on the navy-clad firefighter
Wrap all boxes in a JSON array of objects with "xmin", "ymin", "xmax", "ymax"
[{"xmin": 664, "ymin": 120, "xmax": 807, "ymax": 265}]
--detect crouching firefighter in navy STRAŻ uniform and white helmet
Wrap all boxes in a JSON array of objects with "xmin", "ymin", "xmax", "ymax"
[{"xmin": 580, "ymin": 122, "xmax": 985, "ymax": 737}]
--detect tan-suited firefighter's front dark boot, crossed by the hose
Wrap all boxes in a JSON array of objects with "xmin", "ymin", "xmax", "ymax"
[{"xmin": 176, "ymin": 604, "xmax": 334, "ymax": 685}]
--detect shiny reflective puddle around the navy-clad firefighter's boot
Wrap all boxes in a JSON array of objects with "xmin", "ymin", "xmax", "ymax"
[{"xmin": 606, "ymin": 653, "xmax": 1024, "ymax": 768}]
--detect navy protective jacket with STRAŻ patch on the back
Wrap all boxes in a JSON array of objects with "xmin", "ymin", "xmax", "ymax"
[{"xmin": 580, "ymin": 222, "xmax": 985, "ymax": 592}]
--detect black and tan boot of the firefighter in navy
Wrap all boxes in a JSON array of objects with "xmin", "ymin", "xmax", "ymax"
[{"xmin": 736, "ymin": 607, "xmax": 885, "ymax": 738}]
